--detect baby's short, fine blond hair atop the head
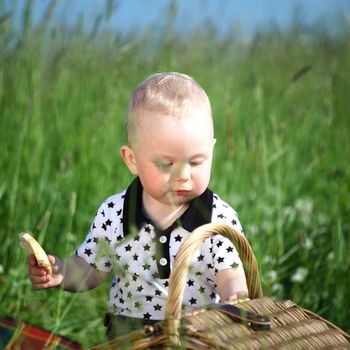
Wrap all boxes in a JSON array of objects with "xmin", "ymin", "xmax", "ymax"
[{"xmin": 126, "ymin": 72, "xmax": 212, "ymax": 144}]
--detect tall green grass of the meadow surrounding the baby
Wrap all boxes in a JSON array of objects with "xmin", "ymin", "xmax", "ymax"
[{"xmin": 0, "ymin": 1, "xmax": 350, "ymax": 346}]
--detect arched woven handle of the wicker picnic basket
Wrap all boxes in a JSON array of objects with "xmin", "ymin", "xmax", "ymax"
[{"xmin": 164, "ymin": 224, "xmax": 262, "ymax": 344}]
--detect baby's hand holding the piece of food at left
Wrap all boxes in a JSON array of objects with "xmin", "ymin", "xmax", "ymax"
[{"xmin": 28, "ymin": 254, "xmax": 63, "ymax": 290}]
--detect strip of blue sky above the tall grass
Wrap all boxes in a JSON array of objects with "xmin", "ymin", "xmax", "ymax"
[{"xmin": 9, "ymin": 0, "xmax": 350, "ymax": 36}]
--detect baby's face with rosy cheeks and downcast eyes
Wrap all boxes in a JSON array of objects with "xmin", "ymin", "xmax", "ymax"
[{"xmin": 121, "ymin": 108, "xmax": 215, "ymax": 207}]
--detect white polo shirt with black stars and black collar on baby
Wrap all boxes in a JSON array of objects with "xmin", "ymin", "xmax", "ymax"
[{"xmin": 76, "ymin": 178, "xmax": 243, "ymax": 320}]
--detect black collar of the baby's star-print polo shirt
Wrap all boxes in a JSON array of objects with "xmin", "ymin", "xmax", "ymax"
[{"xmin": 123, "ymin": 177, "xmax": 213, "ymax": 237}]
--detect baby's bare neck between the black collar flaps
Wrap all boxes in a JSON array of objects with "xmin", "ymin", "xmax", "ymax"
[{"xmin": 142, "ymin": 191, "xmax": 189, "ymax": 230}]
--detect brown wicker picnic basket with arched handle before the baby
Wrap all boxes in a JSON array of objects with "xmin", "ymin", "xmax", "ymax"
[{"xmin": 92, "ymin": 224, "xmax": 350, "ymax": 350}]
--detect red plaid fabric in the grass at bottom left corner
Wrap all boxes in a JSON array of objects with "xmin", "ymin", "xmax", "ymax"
[{"xmin": 0, "ymin": 318, "xmax": 81, "ymax": 350}]
